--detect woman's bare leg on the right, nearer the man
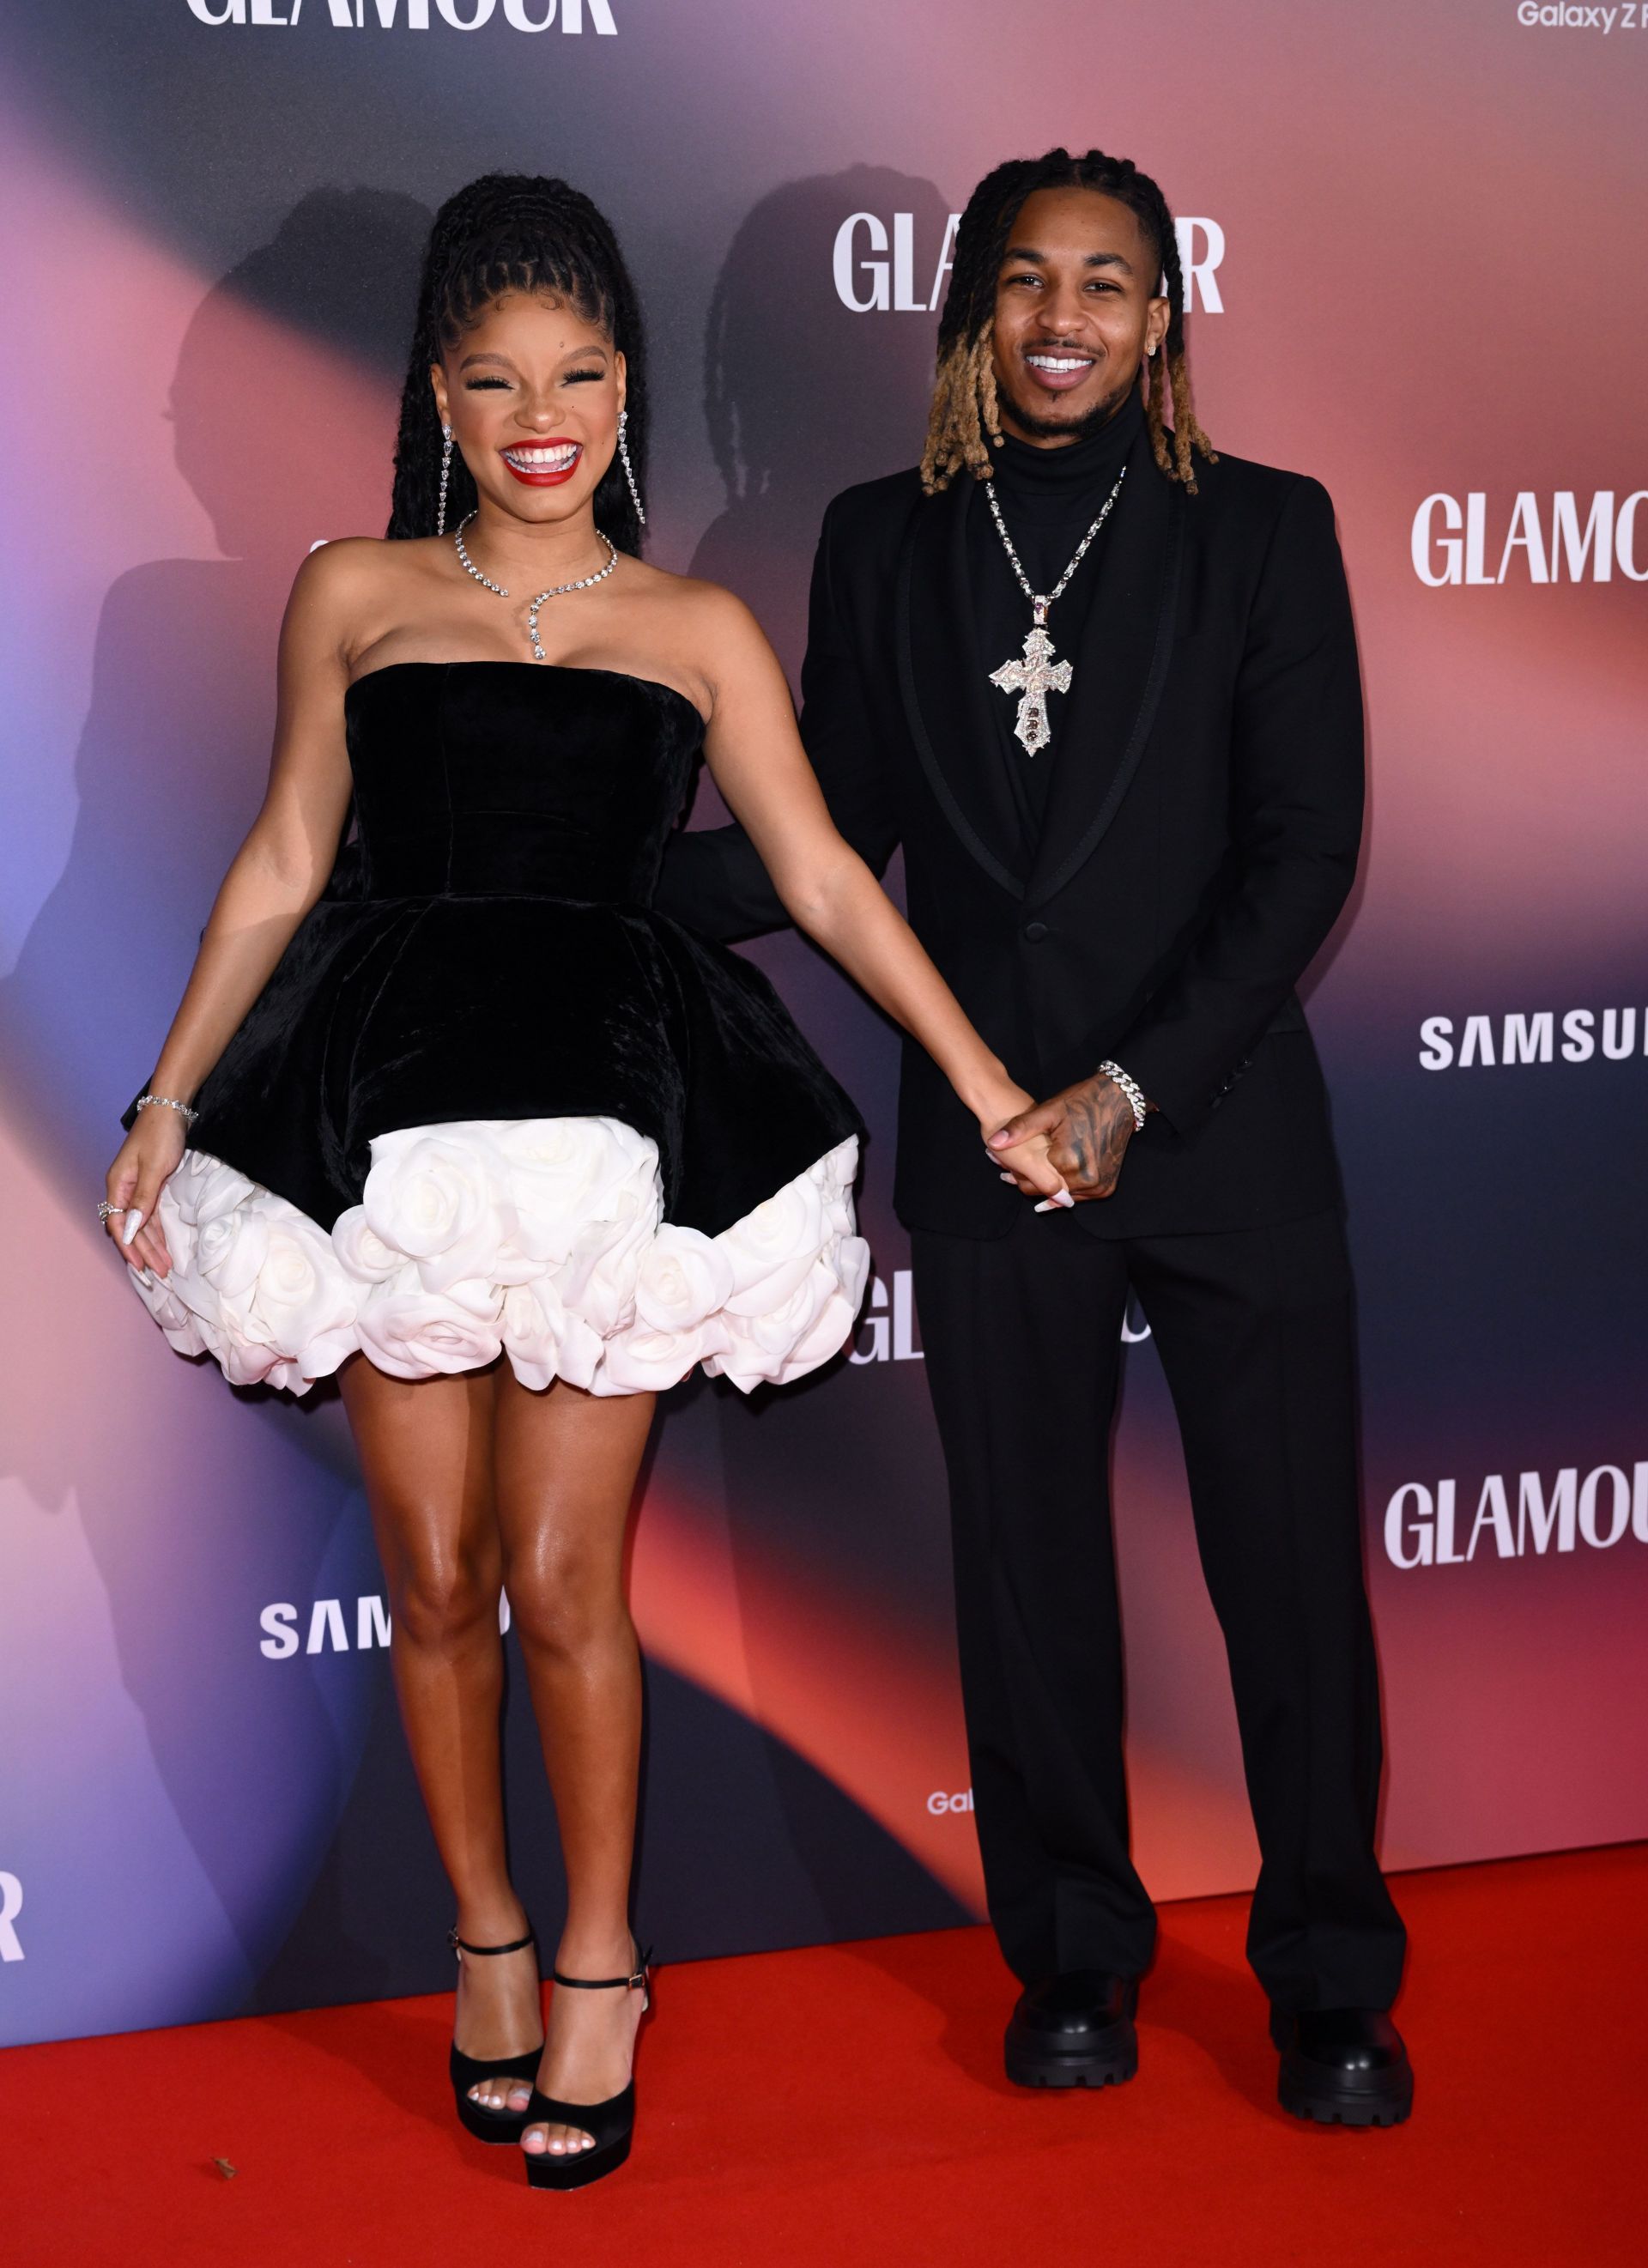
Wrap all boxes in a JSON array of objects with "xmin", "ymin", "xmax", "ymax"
[{"xmin": 492, "ymin": 1370, "xmax": 655, "ymax": 2152}]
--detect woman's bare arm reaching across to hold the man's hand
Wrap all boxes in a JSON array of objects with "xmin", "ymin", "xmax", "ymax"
[{"xmin": 700, "ymin": 592, "xmax": 1063, "ymax": 1198}]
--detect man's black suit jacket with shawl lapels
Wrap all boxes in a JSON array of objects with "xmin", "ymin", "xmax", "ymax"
[{"xmin": 657, "ymin": 435, "xmax": 1362, "ymax": 1239}]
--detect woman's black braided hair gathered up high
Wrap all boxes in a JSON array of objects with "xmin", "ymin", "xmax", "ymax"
[{"xmin": 388, "ymin": 173, "xmax": 646, "ymax": 555}]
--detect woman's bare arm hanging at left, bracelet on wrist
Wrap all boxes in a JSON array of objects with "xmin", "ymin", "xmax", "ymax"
[{"xmin": 109, "ymin": 544, "xmax": 365, "ymax": 1275}]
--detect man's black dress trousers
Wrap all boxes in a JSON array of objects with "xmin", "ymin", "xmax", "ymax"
[{"xmin": 913, "ymin": 1207, "xmax": 1405, "ymax": 2011}]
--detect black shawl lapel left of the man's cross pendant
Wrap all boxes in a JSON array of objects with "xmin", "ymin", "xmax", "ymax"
[{"xmin": 894, "ymin": 474, "xmax": 1033, "ymax": 898}]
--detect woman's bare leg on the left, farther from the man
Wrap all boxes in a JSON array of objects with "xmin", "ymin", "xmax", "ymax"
[{"xmin": 340, "ymin": 1354, "xmax": 542, "ymax": 2107}]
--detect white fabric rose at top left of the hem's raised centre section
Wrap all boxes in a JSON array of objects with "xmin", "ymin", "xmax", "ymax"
[{"xmin": 360, "ymin": 1125, "xmax": 517, "ymax": 1297}]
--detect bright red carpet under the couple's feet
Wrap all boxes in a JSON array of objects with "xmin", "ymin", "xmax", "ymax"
[{"xmin": 0, "ymin": 1847, "xmax": 1648, "ymax": 2268}]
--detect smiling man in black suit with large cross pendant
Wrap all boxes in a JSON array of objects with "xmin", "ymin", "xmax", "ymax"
[{"xmin": 660, "ymin": 149, "xmax": 1412, "ymax": 2125}]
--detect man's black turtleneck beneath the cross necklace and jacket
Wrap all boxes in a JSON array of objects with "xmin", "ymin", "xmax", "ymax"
[{"xmin": 968, "ymin": 392, "xmax": 1145, "ymax": 851}]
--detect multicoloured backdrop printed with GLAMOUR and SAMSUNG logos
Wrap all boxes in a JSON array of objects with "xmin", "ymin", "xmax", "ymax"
[{"xmin": 0, "ymin": 0, "xmax": 1648, "ymax": 2041}]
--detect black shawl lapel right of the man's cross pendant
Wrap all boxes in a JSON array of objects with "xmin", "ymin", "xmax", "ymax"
[{"xmin": 1025, "ymin": 434, "xmax": 1185, "ymax": 905}]
